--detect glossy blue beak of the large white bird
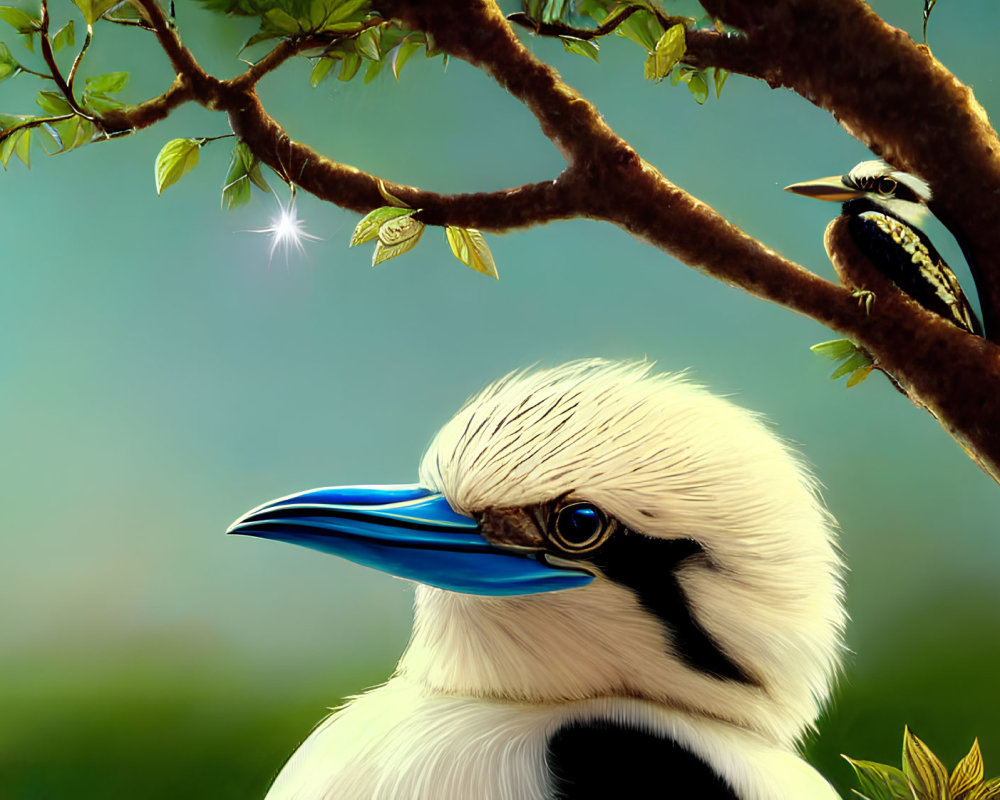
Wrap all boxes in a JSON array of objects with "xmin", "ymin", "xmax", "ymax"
[{"xmin": 228, "ymin": 486, "xmax": 593, "ymax": 595}]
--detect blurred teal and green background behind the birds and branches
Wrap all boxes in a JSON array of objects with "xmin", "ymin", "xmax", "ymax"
[{"xmin": 0, "ymin": 0, "xmax": 1000, "ymax": 798}]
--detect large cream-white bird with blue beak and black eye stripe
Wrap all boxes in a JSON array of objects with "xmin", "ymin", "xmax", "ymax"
[{"xmin": 230, "ymin": 361, "xmax": 845, "ymax": 800}]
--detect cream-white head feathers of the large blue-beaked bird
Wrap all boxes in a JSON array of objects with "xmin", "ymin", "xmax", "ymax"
[{"xmin": 399, "ymin": 361, "xmax": 845, "ymax": 746}]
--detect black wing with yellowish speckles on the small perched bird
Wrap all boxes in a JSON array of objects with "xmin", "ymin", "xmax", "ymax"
[{"xmin": 844, "ymin": 206, "xmax": 982, "ymax": 336}]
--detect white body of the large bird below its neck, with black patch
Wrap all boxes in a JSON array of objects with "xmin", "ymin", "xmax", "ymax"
[{"xmin": 268, "ymin": 679, "xmax": 836, "ymax": 800}]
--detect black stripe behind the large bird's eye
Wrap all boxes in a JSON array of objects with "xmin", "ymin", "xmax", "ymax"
[{"xmin": 589, "ymin": 528, "xmax": 754, "ymax": 683}]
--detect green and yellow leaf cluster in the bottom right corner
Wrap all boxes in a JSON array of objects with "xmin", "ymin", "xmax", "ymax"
[{"xmin": 844, "ymin": 728, "xmax": 1000, "ymax": 800}]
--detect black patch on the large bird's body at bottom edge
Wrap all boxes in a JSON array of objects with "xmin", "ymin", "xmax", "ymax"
[{"xmin": 545, "ymin": 720, "xmax": 739, "ymax": 800}]
